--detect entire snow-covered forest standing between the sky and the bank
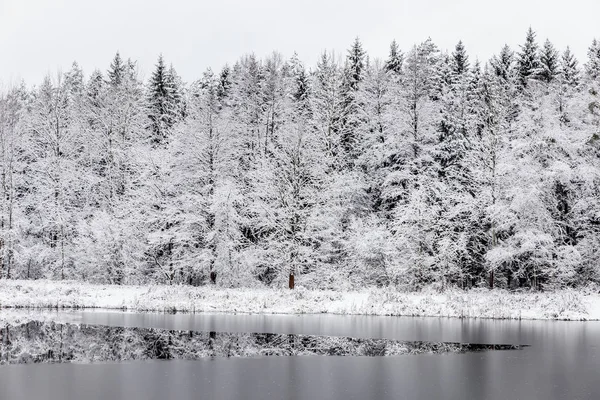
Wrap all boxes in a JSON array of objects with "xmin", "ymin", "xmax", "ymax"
[{"xmin": 0, "ymin": 29, "xmax": 600, "ymax": 290}]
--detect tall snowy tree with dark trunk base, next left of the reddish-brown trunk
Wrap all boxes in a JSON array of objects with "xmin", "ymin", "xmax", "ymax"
[{"xmin": 159, "ymin": 70, "xmax": 248, "ymax": 285}]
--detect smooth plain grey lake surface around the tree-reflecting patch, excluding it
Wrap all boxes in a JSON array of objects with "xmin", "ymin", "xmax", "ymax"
[{"xmin": 0, "ymin": 311, "xmax": 600, "ymax": 400}]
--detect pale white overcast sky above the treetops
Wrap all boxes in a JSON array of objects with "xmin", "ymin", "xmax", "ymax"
[{"xmin": 0, "ymin": 0, "xmax": 600, "ymax": 84}]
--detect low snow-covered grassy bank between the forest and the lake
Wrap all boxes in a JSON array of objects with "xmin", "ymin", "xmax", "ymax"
[{"xmin": 0, "ymin": 280, "xmax": 600, "ymax": 320}]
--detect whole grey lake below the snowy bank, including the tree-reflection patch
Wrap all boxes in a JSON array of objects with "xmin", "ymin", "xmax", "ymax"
[{"xmin": 0, "ymin": 310, "xmax": 600, "ymax": 400}]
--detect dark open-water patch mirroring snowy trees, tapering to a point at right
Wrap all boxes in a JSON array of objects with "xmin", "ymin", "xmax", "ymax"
[{"xmin": 0, "ymin": 321, "xmax": 521, "ymax": 364}]
